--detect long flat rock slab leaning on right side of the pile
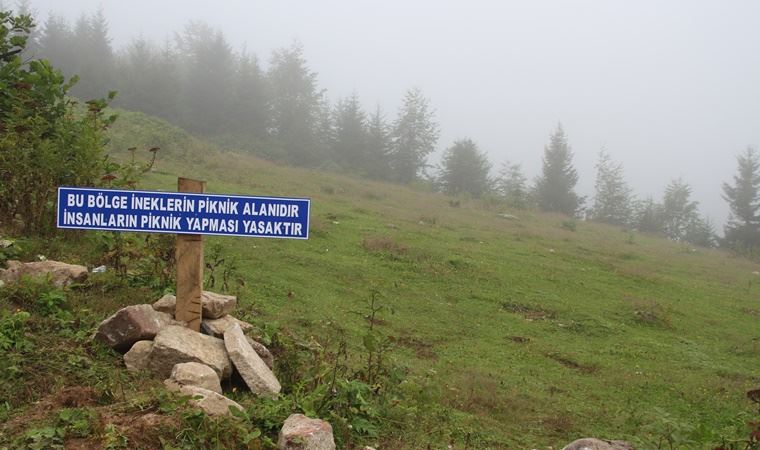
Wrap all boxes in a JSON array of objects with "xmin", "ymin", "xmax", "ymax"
[{"xmin": 224, "ymin": 324, "xmax": 282, "ymax": 395}]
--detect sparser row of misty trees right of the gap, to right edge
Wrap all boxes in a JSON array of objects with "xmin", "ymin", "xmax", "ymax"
[{"xmin": 435, "ymin": 125, "xmax": 760, "ymax": 252}]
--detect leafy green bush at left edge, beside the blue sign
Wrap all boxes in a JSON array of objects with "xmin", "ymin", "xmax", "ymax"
[{"xmin": 0, "ymin": 11, "xmax": 116, "ymax": 234}]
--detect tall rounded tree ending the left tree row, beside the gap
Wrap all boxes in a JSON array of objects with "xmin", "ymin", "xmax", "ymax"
[{"xmin": 391, "ymin": 88, "xmax": 439, "ymax": 183}]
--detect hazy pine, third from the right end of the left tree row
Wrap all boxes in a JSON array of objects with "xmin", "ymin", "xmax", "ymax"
[{"xmin": 332, "ymin": 93, "xmax": 368, "ymax": 170}]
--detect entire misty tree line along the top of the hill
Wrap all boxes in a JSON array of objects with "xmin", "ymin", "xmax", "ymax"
[{"xmin": 10, "ymin": 7, "xmax": 760, "ymax": 250}]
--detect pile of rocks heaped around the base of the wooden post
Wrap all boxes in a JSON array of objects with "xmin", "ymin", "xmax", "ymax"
[{"xmin": 93, "ymin": 291, "xmax": 281, "ymax": 415}]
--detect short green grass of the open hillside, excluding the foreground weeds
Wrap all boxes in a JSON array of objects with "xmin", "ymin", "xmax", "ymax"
[{"xmin": 0, "ymin": 113, "xmax": 760, "ymax": 449}]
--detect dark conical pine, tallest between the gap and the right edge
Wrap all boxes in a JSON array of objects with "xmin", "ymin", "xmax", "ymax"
[{"xmin": 535, "ymin": 124, "xmax": 583, "ymax": 216}]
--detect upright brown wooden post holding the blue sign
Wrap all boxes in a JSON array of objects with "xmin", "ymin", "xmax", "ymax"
[{"xmin": 174, "ymin": 178, "xmax": 206, "ymax": 331}]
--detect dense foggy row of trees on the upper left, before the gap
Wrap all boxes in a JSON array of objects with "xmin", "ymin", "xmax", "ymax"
[{"xmin": 26, "ymin": 11, "xmax": 438, "ymax": 183}]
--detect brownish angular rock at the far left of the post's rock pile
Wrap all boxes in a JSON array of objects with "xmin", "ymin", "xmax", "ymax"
[{"xmin": 93, "ymin": 305, "xmax": 173, "ymax": 351}]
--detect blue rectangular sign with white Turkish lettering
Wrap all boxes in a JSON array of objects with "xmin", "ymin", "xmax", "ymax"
[{"xmin": 58, "ymin": 187, "xmax": 311, "ymax": 239}]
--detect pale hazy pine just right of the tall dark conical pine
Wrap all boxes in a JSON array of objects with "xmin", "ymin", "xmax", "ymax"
[{"xmin": 590, "ymin": 150, "xmax": 632, "ymax": 226}]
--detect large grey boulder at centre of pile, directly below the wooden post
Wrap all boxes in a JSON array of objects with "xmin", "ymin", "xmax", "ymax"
[{"xmin": 148, "ymin": 325, "xmax": 232, "ymax": 379}]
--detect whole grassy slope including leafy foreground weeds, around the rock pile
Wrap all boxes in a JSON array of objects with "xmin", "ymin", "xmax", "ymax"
[{"xmin": 0, "ymin": 112, "xmax": 760, "ymax": 449}]
